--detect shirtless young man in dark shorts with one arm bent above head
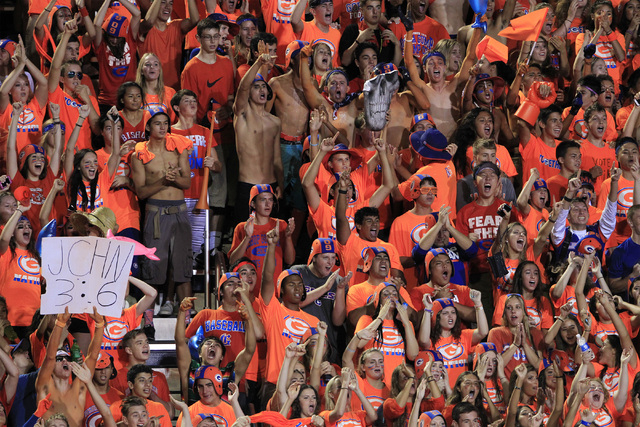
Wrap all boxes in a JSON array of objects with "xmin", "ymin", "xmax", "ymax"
[{"xmin": 233, "ymin": 54, "xmax": 284, "ymax": 222}]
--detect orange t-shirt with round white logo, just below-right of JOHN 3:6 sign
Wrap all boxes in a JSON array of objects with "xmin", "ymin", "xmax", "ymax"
[{"xmin": 84, "ymin": 304, "xmax": 142, "ymax": 369}]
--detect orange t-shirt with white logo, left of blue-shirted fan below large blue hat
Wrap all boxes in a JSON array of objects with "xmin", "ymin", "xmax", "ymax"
[{"xmin": 389, "ymin": 211, "xmax": 429, "ymax": 290}]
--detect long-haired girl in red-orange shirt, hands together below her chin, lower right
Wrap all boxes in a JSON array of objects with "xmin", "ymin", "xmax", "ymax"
[{"xmin": 487, "ymin": 294, "xmax": 542, "ymax": 377}]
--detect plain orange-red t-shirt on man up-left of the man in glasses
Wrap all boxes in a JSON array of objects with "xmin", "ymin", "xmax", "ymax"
[{"xmin": 138, "ymin": 20, "xmax": 182, "ymax": 91}]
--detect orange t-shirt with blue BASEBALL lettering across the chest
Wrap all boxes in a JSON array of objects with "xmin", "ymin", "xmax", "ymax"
[{"xmin": 185, "ymin": 308, "xmax": 245, "ymax": 366}]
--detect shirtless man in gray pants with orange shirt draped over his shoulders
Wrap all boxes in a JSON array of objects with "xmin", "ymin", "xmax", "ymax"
[{"xmin": 131, "ymin": 110, "xmax": 193, "ymax": 314}]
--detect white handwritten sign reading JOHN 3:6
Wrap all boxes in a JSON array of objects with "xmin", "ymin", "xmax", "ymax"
[{"xmin": 40, "ymin": 237, "xmax": 134, "ymax": 317}]
